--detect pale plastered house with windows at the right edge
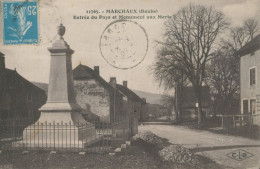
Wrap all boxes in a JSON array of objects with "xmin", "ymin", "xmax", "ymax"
[{"xmin": 237, "ymin": 35, "xmax": 260, "ymax": 125}]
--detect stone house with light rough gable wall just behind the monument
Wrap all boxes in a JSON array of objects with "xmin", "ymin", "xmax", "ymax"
[{"xmin": 73, "ymin": 64, "xmax": 125, "ymax": 123}]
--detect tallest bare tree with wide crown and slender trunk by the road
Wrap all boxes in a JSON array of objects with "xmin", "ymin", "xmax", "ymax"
[{"xmin": 154, "ymin": 4, "xmax": 228, "ymax": 124}]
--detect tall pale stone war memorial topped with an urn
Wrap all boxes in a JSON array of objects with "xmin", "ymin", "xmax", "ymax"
[{"xmin": 13, "ymin": 24, "xmax": 98, "ymax": 149}]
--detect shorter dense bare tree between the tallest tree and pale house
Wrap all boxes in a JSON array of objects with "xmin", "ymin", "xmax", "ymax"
[{"xmin": 207, "ymin": 46, "xmax": 239, "ymax": 115}]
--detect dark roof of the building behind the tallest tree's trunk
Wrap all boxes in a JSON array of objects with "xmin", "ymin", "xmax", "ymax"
[{"xmin": 182, "ymin": 86, "xmax": 211, "ymax": 108}]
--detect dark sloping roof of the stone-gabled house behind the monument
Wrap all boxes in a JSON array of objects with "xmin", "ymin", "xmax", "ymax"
[{"xmin": 73, "ymin": 64, "xmax": 120, "ymax": 91}]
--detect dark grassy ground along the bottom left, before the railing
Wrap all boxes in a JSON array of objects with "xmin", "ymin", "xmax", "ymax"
[{"xmin": 0, "ymin": 146, "xmax": 160, "ymax": 169}]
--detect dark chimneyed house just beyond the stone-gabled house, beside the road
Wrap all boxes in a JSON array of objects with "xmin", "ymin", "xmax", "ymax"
[{"xmin": 116, "ymin": 81, "xmax": 146, "ymax": 135}]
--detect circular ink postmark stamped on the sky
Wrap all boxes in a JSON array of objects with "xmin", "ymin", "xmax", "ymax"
[{"xmin": 99, "ymin": 20, "xmax": 148, "ymax": 69}]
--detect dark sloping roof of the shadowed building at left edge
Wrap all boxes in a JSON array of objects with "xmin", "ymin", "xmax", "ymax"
[{"xmin": 0, "ymin": 68, "xmax": 44, "ymax": 93}]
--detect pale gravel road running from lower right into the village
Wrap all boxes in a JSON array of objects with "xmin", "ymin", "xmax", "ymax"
[{"xmin": 139, "ymin": 125, "xmax": 260, "ymax": 169}]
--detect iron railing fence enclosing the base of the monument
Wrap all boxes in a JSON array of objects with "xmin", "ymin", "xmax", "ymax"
[{"xmin": 0, "ymin": 119, "xmax": 131, "ymax": 152}]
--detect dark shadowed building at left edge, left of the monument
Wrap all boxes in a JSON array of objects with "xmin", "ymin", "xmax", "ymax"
[{"xmin": 0, "ymin": 52, "xmax": 47, "ymax": 121}]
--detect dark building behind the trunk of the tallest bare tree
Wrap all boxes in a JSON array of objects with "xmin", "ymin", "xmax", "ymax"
[{"xmin": 181, "ymin": 86, "xmax": 212, "ymax": 119}]
